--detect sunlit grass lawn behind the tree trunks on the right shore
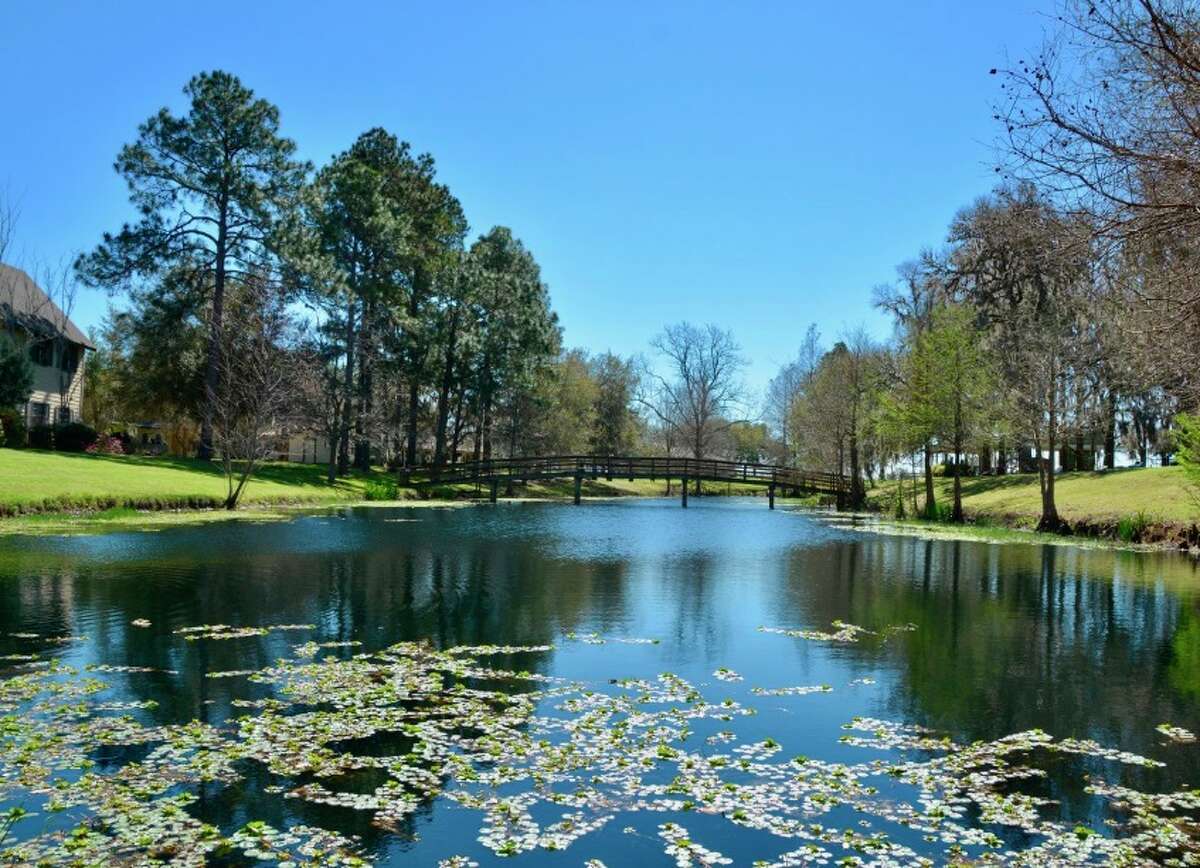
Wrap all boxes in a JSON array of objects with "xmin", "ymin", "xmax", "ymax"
[{"xmin": 872, "ymin": 467, "xmax": 1200, "ymax": 522}]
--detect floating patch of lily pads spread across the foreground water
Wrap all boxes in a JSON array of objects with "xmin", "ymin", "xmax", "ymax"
[{"xmin": 0, "ymin": 624, "xmax": 1200, "ymax": 866}]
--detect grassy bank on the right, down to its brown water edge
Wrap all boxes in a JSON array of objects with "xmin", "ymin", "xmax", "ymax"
[{"xmin": 871, "ymin": 467, "xmax": 1200, "ymax": 544}]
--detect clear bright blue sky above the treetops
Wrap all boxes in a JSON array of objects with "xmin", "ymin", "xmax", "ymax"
[{"xmin": 0, "ymin": 0, "xmax": 1054, "ymax": 389}]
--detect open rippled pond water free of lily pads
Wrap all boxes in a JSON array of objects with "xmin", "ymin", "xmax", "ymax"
[{"xmin": 0, "ymin": 499, "xmax": 1200, "ymax": 866}]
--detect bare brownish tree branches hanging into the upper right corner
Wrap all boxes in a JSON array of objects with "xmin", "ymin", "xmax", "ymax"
[{"xmin": 996, "ymin": 0, "xmax": 1200, "ymax": 405}]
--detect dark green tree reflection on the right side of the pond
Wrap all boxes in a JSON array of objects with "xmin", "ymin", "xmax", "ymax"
[{"xmin": 786, "ymin": 537, "xmax": 1200, "ymax": 819}]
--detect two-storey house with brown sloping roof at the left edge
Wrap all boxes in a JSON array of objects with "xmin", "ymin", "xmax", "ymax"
[{"xmin": 0, "ymin": 263, "xmax": 96, "ymax": 426}]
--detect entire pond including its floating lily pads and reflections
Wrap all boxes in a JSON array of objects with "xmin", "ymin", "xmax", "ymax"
[{"xmin": 0, "ymin": 498, "xmax": 1200, "ymax": 866}]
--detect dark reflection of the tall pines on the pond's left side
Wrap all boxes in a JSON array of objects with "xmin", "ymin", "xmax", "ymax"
[{"xmin": 0, "ymin": 516, "xmax": 648, "ymax": 723}]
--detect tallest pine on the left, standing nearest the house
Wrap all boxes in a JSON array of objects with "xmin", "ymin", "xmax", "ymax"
[{"xmin": 76, "ymin": 71, "xmax": 308, "ymax": 454}]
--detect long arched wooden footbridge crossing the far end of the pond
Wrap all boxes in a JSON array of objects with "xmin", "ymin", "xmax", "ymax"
[{"xmin": 408, "ymin": 455, "xmax": 850, "ymax": 509}]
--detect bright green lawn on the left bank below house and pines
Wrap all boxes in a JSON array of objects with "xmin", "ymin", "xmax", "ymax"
[{"xmin": 0, "ymin": 449, "xmax": 382, "ymax": 513}]
